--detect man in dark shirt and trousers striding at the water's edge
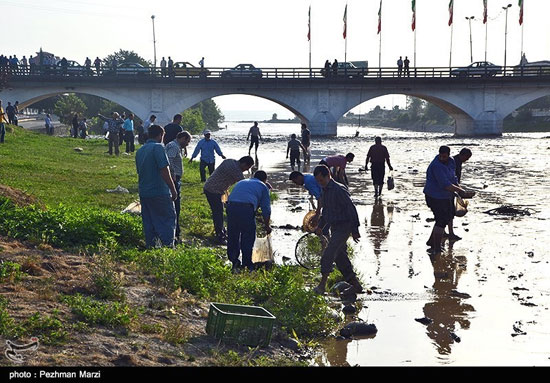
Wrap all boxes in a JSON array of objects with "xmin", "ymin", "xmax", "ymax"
[{"xmin": 313, "ymin": 165, "xmax": 363, "ymax": 294}]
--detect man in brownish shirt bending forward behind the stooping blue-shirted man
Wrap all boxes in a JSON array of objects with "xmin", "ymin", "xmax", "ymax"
[{"xmin": 203, "ymin": 156, "xmax": 254, "ymax": 244}]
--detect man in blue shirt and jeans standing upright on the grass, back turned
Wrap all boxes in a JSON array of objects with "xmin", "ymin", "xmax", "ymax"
[{"xmin": 136, "ymin": 125, "xmax": 178, "ymax": 248}]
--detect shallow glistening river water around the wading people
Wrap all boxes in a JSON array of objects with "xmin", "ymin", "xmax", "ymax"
[{"xmin": 211, "ymin": 122, "xmax": 550, "ymax": 366}]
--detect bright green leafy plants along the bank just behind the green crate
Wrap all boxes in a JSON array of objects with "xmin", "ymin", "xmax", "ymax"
[{"xmin": 123, "ymin": 246, "xmax": 336, "ymax": 337}]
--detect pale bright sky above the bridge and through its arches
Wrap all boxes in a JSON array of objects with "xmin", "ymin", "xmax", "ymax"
[{"xmin": 0, "ymin": 0, "xmax": 550, "ymax": 119}]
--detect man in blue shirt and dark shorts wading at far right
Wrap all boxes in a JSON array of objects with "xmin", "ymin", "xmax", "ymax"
[{"xmin": 424, "ymin": 146, "xmax": 472, "ymax": 254}]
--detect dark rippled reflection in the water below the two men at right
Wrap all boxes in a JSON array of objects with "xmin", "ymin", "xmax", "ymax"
[{"xmin": 424, "ymin": 244, "xmax": 475, "ymax": 355}]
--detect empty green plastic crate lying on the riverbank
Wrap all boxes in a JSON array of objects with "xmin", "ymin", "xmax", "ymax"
[{"xmin": 206, "ymin": 303, "xmax": 275, "ymax": 347}]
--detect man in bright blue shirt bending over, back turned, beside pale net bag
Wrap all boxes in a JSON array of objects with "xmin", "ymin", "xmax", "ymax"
[{"xmin": 227, "ymin": 170, "xmax": 271, "ymax": 271}]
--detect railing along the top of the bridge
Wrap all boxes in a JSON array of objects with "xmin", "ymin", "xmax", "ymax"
[{"xmin": 4, "ymin": 64, "xmax": 550, "ymax": 81}]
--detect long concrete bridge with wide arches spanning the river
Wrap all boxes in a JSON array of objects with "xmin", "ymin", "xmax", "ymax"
[{"xmin": 0, "ymin": 68, "xmax": 550, "ymax": 136}]
